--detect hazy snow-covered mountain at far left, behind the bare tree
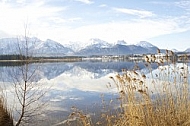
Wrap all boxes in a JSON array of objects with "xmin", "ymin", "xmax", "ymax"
[{"xmin": 0, "ymin": 37, "xmax": 73, "ymax": 56}]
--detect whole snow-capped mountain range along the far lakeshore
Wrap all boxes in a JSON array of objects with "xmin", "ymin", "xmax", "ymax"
[{"xmin": 0, "ymin": 37, "xmax": 190, "ymax": 57}]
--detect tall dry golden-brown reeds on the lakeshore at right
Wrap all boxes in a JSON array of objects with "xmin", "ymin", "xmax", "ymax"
[{"xmin": 67, "ymin": 50, "xmax": 190, "ymax": 126}]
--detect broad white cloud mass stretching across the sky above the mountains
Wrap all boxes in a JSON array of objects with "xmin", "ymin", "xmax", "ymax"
[{"xmin": 0, "ymin": 0, "xmax": 190, "ymax": 49}]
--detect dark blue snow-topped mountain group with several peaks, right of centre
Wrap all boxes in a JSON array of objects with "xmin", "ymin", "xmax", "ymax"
[{"xmin": 75, "ymin": 39, "xmax": 158, "ymax": 55}]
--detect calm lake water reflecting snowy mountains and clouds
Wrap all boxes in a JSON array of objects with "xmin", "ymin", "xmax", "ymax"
[{"xmin": 0, "ymin": 61, "xmax": 189, "ymax": 126}]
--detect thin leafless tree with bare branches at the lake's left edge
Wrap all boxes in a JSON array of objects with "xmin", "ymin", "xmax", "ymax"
[{"xmin": 10, "ymin": 25, "xmax": 46, "ymax": 126}]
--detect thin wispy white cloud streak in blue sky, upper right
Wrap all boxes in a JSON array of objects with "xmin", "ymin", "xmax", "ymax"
[{"xmin": 113, "ymin": 8, "xmax": 155, "ymax": 18}]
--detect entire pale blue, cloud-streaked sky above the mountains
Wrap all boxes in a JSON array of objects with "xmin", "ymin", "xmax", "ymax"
[{"xmin": 0, "ymin": 0, "xmax": 190, "ymax": 51}]
